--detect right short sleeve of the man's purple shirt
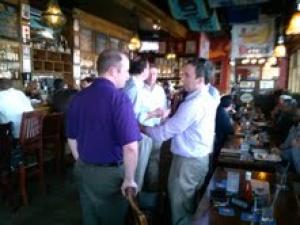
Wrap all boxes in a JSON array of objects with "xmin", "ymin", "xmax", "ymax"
[{"xmin": 114, "ymin": 95, "xmax": 142, "ymax": 146}]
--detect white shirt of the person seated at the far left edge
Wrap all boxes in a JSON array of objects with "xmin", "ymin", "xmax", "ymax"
[{"xmin": 0, "ymin": 88, "xmax": 33, "ymax": 138}]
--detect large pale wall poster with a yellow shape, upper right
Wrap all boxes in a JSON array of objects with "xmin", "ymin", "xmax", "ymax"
[{"xmin": 231, "ymin": 20, "xmax": 275, "ymax": 58}]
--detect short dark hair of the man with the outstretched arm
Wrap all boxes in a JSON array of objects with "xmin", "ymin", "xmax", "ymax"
[{"xmin": 187, "ymin": 58, "xmax": 215, "ymax": 84}]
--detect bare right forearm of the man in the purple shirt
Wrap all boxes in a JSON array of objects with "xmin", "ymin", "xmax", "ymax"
[{"xmin": 123, "ymin": 142, "xmax": 138, "ymax": 181}]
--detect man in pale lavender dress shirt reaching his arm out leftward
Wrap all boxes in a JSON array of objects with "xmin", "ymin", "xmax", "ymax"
[{"xmin": 144, "ymin": 59, "xmax": 217, "ymax": 225}]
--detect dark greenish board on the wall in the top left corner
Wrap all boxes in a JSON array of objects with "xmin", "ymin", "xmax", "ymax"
[{"xmin": 0, "ymin": 3, "xmax": 19, "ymax": 40}]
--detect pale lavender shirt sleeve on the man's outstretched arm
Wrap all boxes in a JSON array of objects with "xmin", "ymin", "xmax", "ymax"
[{"xmin": 145, "ymin": 103, "xmax": 201, "ymax": 141}]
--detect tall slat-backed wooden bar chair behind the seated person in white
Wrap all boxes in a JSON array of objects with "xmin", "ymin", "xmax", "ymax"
[{"xmin": 19, "ymin": 111, "xmax": 46, "ymax": 205}]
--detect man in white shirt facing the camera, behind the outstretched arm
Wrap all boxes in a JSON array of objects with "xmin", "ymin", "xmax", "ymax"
[{"xmin": 140, "ymin": 64, "xmax": 167, "ymax": 191}]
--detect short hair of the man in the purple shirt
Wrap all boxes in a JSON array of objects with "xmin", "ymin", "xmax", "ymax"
[{"xmin": 97, "ymin": 49, "xmax": 125, "ymax": 76}]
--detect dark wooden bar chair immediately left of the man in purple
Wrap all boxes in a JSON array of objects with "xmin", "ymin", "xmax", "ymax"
[{"xmin": 42, "ymin": 113, "xmax": 64, "ymax": 175}]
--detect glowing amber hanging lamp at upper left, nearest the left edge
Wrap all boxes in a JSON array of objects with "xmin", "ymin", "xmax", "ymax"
[{"xmin": 42, "ymin": 0, "xmax": 66, "ymax": 29}]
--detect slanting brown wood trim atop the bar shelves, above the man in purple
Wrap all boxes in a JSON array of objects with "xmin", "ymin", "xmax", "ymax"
[{"xmin": 73, "ymin": 9, "xmax": 132, "ymax": 41}]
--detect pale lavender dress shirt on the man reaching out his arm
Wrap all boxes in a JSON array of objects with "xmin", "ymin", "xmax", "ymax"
[{"xmin": 146, "ymin": 87, "xmax": 218, "ymax": 158}]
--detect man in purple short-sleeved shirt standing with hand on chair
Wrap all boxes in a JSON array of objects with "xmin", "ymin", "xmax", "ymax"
[{"xmin": 67, "ymin": 50, "xmax": 141, "ymax": 225}]
